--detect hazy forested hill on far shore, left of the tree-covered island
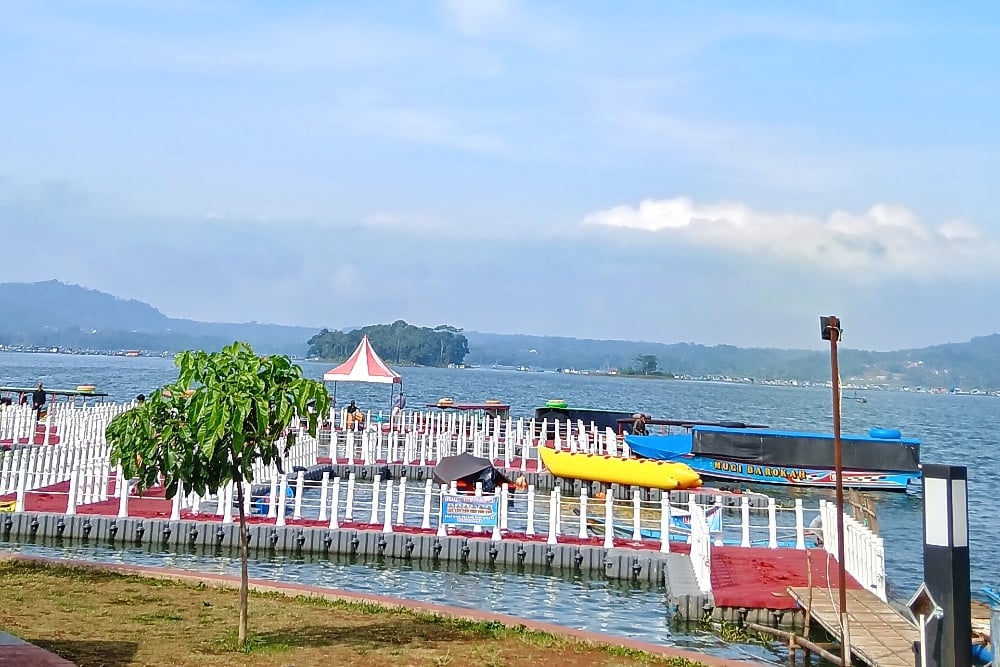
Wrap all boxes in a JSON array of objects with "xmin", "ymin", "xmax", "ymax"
[{"xmin": 0, "ymin": 280, "xmax": 316, "ymax": 355}]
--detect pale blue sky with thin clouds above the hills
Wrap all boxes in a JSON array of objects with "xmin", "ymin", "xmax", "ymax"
[{"xmin": 0, "ymin": 0, "xmax": 1000, "ymax": 349}]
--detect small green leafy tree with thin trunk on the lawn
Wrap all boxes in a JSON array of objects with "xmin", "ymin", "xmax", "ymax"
[{"xmin": 106, "ymin": 342, "xmax": 330, "ymax": 648}]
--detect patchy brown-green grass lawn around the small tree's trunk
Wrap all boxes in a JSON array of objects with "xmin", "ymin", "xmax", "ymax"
[{"xmin": 0, "ymin": 561, "xmax": 712, "ymax": 667}]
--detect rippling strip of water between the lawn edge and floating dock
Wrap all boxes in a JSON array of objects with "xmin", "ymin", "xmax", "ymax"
[{"xmin": 0, "ymin": 540, "xmax": 787, "ymax": 664}]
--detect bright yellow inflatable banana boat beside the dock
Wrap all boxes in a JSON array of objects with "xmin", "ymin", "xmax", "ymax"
[{"xmin": 538, "ymin": 447, "xmax": 701, "ymax": 491}]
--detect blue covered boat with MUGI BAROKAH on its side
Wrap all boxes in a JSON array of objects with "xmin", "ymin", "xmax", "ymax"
[{"xmin": 625, "ymin": 425, "xmax": 920, "ymax": 491}]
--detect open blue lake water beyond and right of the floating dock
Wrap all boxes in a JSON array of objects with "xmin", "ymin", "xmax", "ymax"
[{"xmin": 0, "ymin": 353, "xmax": 1000, "ymax": 628}]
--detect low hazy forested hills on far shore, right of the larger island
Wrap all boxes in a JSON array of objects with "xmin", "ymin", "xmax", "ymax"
[{"xmin": 465, "ymin": 331, "xmax": 1000, "ymax": 390}]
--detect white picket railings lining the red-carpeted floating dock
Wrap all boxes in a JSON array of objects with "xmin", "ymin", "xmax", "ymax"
[{"xmin": 0, "ymin": 403, "xmax": 885, "ymax": 600}]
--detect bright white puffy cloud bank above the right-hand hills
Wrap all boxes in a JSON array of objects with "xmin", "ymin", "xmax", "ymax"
[{"xmin": 583, "ymin": 197, "xmax": 1000, "ymax": 281}]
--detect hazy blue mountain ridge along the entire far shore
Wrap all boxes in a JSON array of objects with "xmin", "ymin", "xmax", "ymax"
[{"xmin": 0, "ymin": 280, "xmax": 1000, "ymax": 391}]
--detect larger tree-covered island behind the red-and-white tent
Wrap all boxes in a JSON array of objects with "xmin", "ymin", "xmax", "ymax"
[{"xmin": 308, "ymin": 320, "xmax": 469, "ymax": 367}]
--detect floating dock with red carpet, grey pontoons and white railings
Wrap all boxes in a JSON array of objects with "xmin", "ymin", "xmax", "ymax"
[{"xmin": 0, "ymin": 403, "xmax": 884, "ymax": 628}]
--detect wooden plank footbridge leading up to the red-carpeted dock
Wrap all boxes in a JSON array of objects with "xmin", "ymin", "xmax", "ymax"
[{"xmin": 788, "ymin": 587, "xmax": 919, "ymax": 667}]
